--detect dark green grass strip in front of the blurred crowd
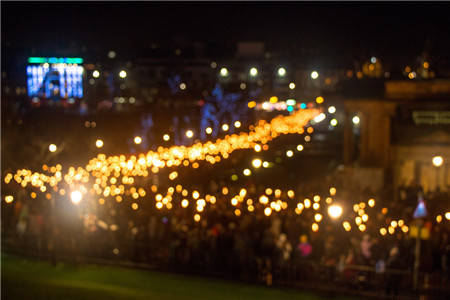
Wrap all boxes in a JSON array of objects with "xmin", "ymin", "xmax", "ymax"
[{"xmin": 1, "ymin": 254, "xmax": 356, "ymax": 300}]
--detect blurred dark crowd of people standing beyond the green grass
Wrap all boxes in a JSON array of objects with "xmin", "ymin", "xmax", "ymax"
[{"xmin": 2, "ymin": 175, "xmax": 450, "ymax": 293}]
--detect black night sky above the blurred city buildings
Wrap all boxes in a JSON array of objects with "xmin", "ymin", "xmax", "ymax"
[{"xmin": 1, "ymin": 2, "xmax": 450, "ymax": 66}]
